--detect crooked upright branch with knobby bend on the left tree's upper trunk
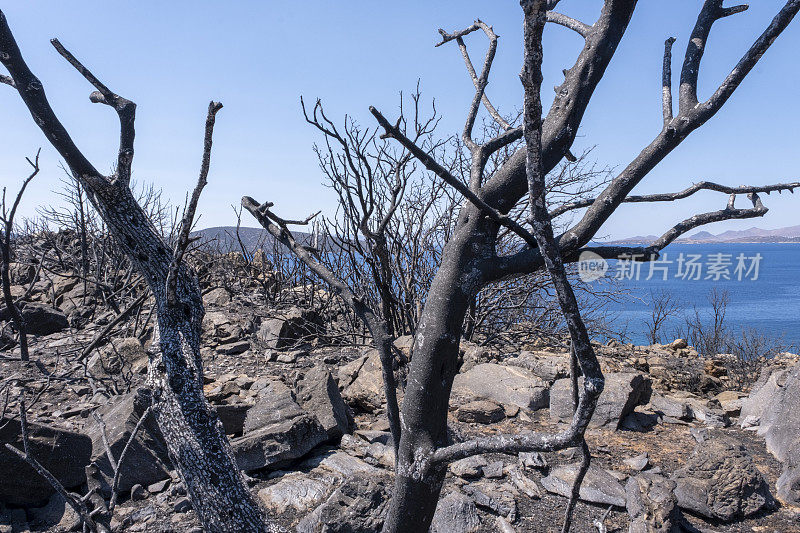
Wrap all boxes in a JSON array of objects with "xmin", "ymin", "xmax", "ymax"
[{"xmin": 50, "ymin": 39, "xmax": 136, "ymax": 187}]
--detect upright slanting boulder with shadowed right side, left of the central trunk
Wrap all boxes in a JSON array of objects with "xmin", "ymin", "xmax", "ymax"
[{"xmin": 297, "ymin": 365, "xmax": 350, "ymax": 439}]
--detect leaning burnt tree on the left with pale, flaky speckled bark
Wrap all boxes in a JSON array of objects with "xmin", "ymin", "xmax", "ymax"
[{"xmin": 0, "ymin": 12, "xmax": 281, "ymax": 532}]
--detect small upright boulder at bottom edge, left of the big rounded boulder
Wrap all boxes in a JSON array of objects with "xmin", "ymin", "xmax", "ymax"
[{"xmin": 625, "ymin": 473, "xmax": 683, "ymax": 533}]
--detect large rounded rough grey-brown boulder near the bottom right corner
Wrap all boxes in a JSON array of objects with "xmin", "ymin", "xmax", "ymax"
[{"xmin": 672, "ymin": 438, "xmax": 773, "ymax": 522}]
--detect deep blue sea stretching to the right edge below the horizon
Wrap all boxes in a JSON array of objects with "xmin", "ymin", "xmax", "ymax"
[{"xmin": 588, "ymin": 243, "xmax": 800, "ymax": 353}]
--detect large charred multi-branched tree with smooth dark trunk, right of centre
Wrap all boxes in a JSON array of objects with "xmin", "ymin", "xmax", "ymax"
[{"xmin": 244, "ymin": 0, "xmax": 800, "ymax": 533}]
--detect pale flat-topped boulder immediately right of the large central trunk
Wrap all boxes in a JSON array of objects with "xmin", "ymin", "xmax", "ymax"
[{"xmin": 453, "ymin": 363, "xmax": 548, "ymax": 410}]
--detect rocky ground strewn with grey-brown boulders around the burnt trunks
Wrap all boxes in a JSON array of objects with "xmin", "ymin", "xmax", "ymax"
[{"xmin": 0, "ymin": 264, "xmax": 800, "ymax": 533}]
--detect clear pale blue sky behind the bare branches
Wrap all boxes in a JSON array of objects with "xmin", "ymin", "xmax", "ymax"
[{"xmin": 0, "ymin": 0, "xmax": 800, "ymax": 237}]
